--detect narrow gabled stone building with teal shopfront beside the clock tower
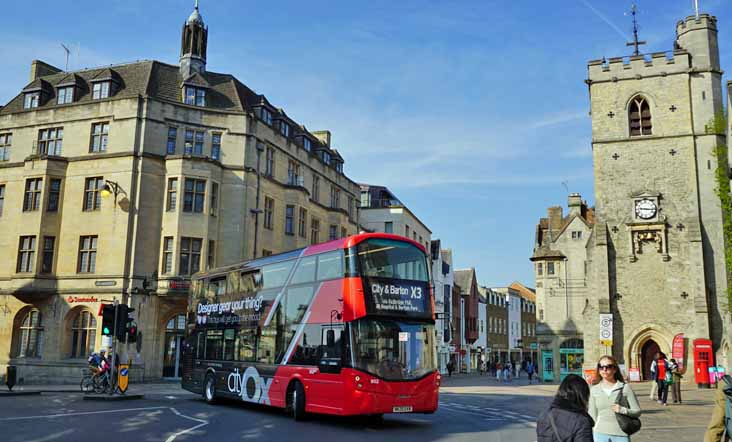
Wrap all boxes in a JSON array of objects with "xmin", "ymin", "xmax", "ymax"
[{"xmin": 531, "ymin": 193, "xmax": 595, "ymax": 381}]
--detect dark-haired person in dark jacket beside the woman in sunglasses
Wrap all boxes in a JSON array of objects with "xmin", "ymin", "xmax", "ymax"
[{"xmin": 536, "ymin": 374, "xmax": 595, "ymax": 442}]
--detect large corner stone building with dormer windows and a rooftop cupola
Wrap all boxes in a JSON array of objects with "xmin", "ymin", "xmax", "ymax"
[{"xmin": 0, "ymin": 1, "xmax": 359, "ymax": 382}]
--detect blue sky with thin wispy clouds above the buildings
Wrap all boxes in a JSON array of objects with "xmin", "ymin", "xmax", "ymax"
[{"xmin": 0, "ymin": 0, "xmax": 732, "ymax": 286}]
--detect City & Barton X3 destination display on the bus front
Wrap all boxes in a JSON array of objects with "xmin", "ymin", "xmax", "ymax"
[{"xmin": 364, "ymin": 278, "xmax": 432, "ymax": 318}]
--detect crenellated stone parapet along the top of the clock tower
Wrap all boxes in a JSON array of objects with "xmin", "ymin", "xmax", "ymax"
[{"xmin": 587, "ymin": 50, "xmax": 692, "ymax": 83}]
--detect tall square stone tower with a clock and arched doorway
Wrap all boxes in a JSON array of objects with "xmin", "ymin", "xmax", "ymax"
[{"xmin": 583, "ymin": 14, "xmax": 732, "ymax": 375}]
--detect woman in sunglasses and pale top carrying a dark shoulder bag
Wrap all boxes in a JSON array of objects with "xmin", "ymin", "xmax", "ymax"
[{"xmin": 588, "ymin": 356, "xmax": 641, "ymax": 442}]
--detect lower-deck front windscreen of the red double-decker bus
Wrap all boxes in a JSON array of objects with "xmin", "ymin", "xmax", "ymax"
[{"xmin": 351, "ymin": 318, "xmax": 437, "ymax": 381}]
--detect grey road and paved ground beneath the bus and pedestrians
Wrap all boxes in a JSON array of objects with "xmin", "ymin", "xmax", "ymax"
[{"xmin": 0, "ymin": 375, "xmax": 714, "ymax": 442}]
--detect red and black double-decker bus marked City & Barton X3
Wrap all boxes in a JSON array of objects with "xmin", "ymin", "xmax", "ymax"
[{"xmin": 181, "ymin": 233, "xmax": 440, "ymax": 419}]
